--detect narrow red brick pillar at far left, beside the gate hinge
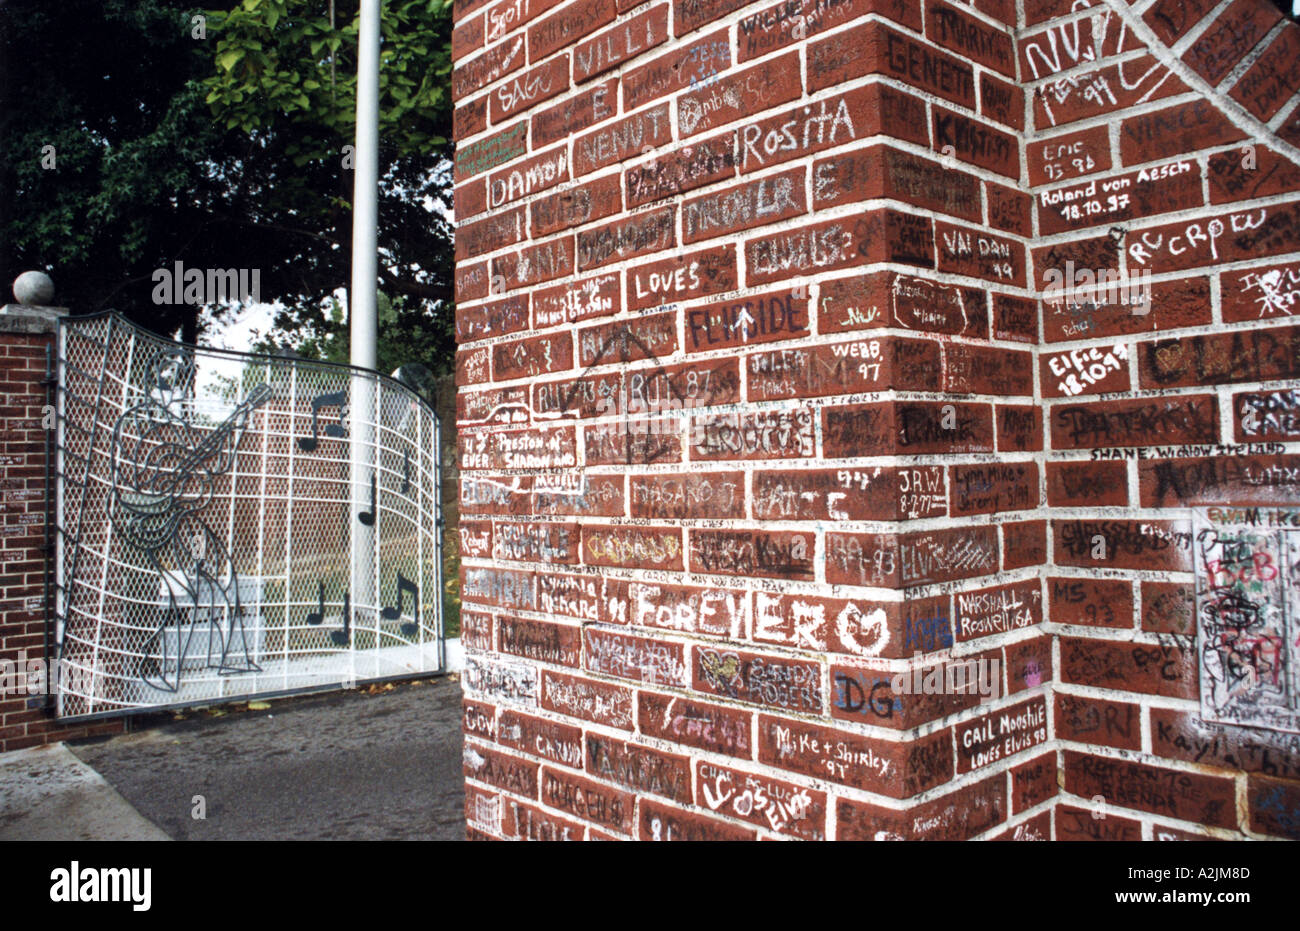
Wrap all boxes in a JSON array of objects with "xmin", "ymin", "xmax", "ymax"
[{"xmin": 0, "ymin": 304, "xmax": 122, "ymax": 752}]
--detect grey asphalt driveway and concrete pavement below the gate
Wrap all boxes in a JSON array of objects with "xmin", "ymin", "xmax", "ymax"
[{"xmin": 0, "ymin": 677, "xmax": 465, "ymax": 840}]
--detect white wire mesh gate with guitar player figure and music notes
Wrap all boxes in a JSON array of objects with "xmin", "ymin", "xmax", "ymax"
[{"xmin": 55, "ymin": 313, "xmax": 443, "ymax": 718}]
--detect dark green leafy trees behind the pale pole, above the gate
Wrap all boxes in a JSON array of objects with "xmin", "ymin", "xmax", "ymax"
[{"xmin": 0, "ymin": 0, "xmax": 454, "ymax": 372}]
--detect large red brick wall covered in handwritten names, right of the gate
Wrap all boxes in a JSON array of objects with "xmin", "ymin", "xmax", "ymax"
[{"xmin": 452, "ymin": 0, "xmax": 1300, "ymax": 839}]
